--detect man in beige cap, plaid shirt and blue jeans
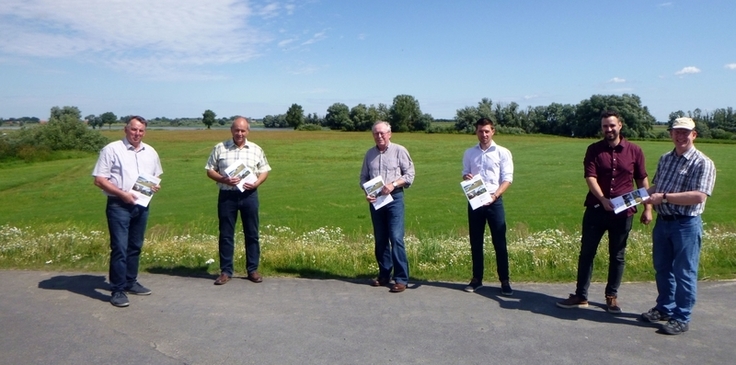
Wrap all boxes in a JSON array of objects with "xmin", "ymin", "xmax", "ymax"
[{"xmin": 641, "ymin": 118, "xmax": 716, "ymax": 335}]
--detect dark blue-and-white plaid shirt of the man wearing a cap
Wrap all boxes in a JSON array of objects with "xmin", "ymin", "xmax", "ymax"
[{"xmin": 652, "ymin": 147, "xmax": 716, "ymax": 216}]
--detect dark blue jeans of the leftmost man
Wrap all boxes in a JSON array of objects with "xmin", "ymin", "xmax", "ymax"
[{"xmin": 105, "ymin": 198, "xmax": 148, "ymax": 292}]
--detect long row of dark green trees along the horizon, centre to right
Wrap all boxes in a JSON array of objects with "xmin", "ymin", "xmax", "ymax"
[{"xmin": 262, "ymin": 94, "xmax": 736, "ymax": 139}]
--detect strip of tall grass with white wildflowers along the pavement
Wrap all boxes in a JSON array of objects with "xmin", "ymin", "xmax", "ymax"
[{"xmin": 0, "ymin": 225, "xmax": 736, "ymax": 282}]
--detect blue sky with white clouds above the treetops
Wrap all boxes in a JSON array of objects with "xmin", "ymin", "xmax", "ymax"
[{"xmin": 0, "ymin": 0, "xmax": 736, "ymax": 121}]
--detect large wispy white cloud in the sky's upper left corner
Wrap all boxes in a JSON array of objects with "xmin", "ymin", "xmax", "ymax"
[{"xmin": 0, "ymin": 0, "xmax": 279, "ymax": 78}]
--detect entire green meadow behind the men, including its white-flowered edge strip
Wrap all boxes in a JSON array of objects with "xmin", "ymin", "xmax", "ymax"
[{"xmin": 0, "ymin": 130, "xmax": 736, "ymax": 281}]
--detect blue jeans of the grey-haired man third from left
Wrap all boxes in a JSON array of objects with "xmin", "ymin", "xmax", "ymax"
[{"xmin": 370, "ymin": 192, "xmax": 409, "ymax": 285}]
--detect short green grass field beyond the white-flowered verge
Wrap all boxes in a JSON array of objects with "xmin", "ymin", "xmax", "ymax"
[{"xmin": 0, "ymin": 130, "xmax": 736, "ymax": 236}]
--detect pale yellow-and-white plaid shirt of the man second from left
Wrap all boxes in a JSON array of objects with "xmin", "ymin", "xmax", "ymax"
[{"xmin": 204, "ymin": 139, "xmax": 271, "ymax": 190}]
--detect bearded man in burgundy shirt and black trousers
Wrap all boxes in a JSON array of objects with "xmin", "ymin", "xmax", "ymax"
[{"xmin": 557, "ymin": 111, "xmax": 652, "ymax": 313}]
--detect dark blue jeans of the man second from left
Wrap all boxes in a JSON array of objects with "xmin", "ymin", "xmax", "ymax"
[{"xmin": 217, "ymin": 190, "xmax": 261, "ymax": 277}]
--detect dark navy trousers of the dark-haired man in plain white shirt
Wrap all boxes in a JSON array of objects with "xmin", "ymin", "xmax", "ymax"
[{"xmin": 468, "ymin": 197, "xmax": 509, "ymax": 281}]
